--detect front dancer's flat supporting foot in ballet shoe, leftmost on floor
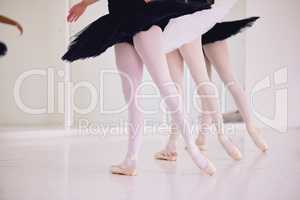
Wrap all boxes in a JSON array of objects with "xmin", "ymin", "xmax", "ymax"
[{"xmin": 110, "ymin": 161, "xmax": 137, "ymax": 176}]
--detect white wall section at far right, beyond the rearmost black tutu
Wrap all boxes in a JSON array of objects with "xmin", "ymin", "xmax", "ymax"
[{"xmin": 246, "ymin": 0, "xmax": 300, "ymax": 127}]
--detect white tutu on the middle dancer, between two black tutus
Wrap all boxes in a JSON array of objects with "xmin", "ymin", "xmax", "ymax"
[{"xmin": 163, "ymin": 0, "xmax": 238, "ymax": 53}]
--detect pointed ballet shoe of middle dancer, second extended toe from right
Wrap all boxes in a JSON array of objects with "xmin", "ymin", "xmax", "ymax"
[{"xmin": 218, "ymin": 134, "xmax": 242, "ymax": 161}]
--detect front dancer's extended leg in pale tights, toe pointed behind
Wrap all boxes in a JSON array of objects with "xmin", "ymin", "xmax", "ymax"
[{"xmin": 133, "ymin": 26, "xmax": 208, "ymax": 168}]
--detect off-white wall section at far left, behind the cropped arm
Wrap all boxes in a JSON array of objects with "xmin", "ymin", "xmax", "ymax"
[{"xmin": 0, "ymin": 0, "xmax": 66, "ymax": 126}]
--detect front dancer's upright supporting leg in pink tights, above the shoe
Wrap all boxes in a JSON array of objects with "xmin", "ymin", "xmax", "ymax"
[{"xmin": 115, "ymin": 43, "xmax": 144, "ymax": 167}]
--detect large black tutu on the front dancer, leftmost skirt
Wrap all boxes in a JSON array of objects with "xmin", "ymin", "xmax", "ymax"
[{"xmin": 62, "ymin": 0, "xmax": 214, "ymax": 62}]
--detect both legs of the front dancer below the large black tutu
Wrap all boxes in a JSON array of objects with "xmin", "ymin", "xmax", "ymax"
[{"xmin": 111, "ymin": 26, "xmax": 215, "ymax": 175}]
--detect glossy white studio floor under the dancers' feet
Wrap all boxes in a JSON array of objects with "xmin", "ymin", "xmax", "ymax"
[{"xmin": 0, "ymin": 129, "xmax": 300, "ymax": 200}]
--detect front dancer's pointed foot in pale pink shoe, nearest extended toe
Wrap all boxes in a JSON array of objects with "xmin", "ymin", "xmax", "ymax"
[{"xmin": 187, "ymin": 146, "xmax": 217, "ymax": 176}]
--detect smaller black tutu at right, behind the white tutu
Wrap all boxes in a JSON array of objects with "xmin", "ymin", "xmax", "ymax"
[{"xmin": 202, "ymin": 17, "xmax": 259, "ymax": 45}]
